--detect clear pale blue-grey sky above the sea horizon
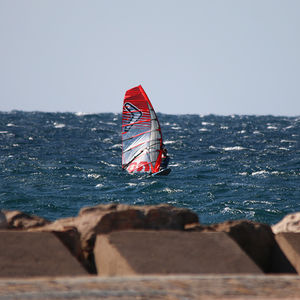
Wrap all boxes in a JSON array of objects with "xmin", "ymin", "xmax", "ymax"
[{"xmin": 0, "ymin": 0, "xmax": 300, "ymax": 116}]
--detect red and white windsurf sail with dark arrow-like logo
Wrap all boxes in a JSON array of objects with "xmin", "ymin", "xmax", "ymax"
[{"xmin": 122, "ymin": 85, "xmax": 162, "ymax": 173}]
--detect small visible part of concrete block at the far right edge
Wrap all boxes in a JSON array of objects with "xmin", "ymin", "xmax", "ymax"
[{"xmin": 275, "ymin": 232, "xmax": 300, "ymax": 274}]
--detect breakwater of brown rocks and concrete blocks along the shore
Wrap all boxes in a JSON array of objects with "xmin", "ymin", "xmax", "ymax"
[{"xmin": 0, "ymin": 204, "xmax": 300, "ymax": 277}]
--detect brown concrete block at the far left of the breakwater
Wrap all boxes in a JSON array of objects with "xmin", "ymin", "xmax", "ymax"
[{"xmin": 0, "ymin": 230, "xmax": 87, "ymax": 277}]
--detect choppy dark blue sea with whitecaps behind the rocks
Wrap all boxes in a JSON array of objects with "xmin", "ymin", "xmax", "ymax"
[{"xmin": 0, "ymin": 111, "xmax": 300, "ymax": 224}]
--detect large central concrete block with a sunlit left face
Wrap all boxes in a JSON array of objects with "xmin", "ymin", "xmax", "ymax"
[{"xmin": 94, "ymin": 231, "xmax": 263, "ymax": 276}]
